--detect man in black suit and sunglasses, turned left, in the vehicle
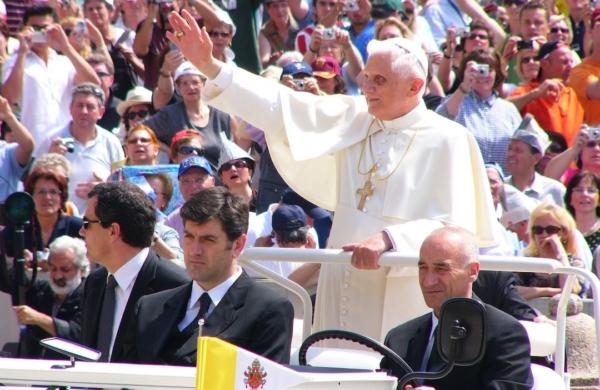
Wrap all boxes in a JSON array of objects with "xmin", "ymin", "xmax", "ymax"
[{"xmin": 80, "ymin": 182, "xmax": 189, "ymax": 362}]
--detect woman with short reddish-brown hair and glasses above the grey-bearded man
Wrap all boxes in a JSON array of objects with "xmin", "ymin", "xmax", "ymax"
[{"xmin": 2, "ymin": 169, "xmax": 83, "ymax": 260}]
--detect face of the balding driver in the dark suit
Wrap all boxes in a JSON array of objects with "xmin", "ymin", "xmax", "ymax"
[{"xmin": 419, "ymin": 235, "xmax": 479, "ymax": 315}]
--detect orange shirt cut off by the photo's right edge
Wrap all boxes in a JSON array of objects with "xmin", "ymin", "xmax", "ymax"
[{"xmin": 569, "ymin": 57, "xmax": 600, "ymax": 126}]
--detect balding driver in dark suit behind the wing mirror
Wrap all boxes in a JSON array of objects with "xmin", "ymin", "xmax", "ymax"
[{"xmin": 381, "ymin": 227, "xmax": 533, "ymax": 390}]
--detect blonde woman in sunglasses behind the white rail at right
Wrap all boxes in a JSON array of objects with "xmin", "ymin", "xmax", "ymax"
[{"xmin": 516, "ymin": 203, "xmax": 584, "ymax": 299}]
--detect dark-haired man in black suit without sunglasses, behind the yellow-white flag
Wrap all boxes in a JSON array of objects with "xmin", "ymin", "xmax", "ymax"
[{"xmin": 129, "ymin": 187, "xmax": 294, "ymax": 365}]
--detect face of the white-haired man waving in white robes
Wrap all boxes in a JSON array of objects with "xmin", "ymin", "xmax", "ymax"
[{"xmin": 360, "ymin": 53, "xmax": 424, "ymax": 120}]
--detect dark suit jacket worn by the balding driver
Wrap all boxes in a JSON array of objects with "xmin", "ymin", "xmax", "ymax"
[{"xmin": 381, "ymin": 304, "xmax": 533, "ymax": 390}]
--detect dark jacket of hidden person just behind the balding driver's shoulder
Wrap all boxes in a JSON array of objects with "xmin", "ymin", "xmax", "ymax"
[{"xmin": 473, "ymin": 271, "xmax": 537, "ymax": 321}]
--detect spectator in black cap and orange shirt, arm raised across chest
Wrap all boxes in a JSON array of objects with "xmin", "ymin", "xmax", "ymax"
[{"xmin": 509, "ymin": 41, "xmax": 584, "ymax": 145}]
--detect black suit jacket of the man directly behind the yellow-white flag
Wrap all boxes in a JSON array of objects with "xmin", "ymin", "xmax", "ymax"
[{"xmin": 128, "ymin": 272, "xmax": 294, "ymax": 365}]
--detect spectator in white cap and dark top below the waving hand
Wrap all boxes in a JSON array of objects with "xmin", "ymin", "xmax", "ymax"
[{"xmin": 144, "ymin": 62, "xmax": 236, "ymax": 166}]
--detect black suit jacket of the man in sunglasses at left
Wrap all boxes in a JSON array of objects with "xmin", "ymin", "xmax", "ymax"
[{"xmin": 81, "ymin": 250, "xmax": 190, "ymax": 362}]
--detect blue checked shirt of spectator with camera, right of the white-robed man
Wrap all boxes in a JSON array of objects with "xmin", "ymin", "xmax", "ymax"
[{"xmin": 437, "ymin": 92, "xmax": 521, "ymax": 172}]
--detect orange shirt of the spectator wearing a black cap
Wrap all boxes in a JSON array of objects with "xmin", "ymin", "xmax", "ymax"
[{"xmin": 510, "ymin": 81, "xmax": 584, "ymax": 146}]
